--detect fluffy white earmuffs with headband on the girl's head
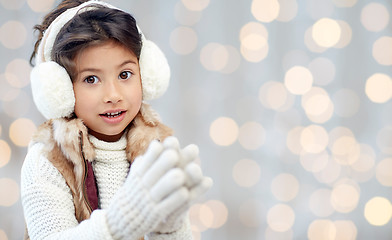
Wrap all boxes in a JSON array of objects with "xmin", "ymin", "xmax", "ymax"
[{"xmin": 30, "ymin": 0, "xmax": 170, "ymax": 119}]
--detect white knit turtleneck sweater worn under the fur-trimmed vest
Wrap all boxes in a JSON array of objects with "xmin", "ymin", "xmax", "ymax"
[{"xmin": 21, "ymin": 136, "xmax": 192, "ymax": 240}]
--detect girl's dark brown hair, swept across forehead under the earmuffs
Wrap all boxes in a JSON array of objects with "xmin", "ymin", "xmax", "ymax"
[{"xmin": 30, "ymin": 0, "xmax": 142, "ymax": 79}]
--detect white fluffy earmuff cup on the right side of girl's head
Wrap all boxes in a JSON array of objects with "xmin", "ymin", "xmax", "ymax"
[{"xmin": 139, "ymin": 39, "xmax": 170, "ymax": 100}]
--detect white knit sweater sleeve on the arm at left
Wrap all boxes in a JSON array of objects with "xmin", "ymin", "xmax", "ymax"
[{"xmin": 21, "ymin": 144, "xmax": 112, "ymax": 240}]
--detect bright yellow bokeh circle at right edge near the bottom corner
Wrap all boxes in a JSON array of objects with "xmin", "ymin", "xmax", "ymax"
[{"xmin": 364, "ymin": 196, "xmax": 392, "ymax": 226}]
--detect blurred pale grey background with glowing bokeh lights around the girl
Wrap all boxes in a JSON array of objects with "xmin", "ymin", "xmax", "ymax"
[{"xmin": 0, "ymin": 0, "xmax": 392, "ymax": 240}]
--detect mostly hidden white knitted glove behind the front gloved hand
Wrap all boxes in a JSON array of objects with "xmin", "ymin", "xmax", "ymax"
[{"xmin": 152, "ymin": 137, "xmax": 212, "ymax": 235}]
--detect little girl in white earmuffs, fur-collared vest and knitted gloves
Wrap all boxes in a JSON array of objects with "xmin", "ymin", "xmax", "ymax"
[{"xmin": 21, "ymin": 0, "xmax": 212, "ymax": 239}]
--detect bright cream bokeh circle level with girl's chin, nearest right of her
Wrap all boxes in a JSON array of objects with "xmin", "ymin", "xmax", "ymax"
[{"xmin": 210, "ymin": 117, "xmax": 239, "ymax": 146}]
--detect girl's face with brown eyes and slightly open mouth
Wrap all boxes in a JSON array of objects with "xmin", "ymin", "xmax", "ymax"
[{"xmin": 73, "ymin": 41, "xmax": 142, "ymax": 142}]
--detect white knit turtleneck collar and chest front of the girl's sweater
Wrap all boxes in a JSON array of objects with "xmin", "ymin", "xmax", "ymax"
[{"xmin": 89, "ymin": 135, "xmax": 129, "ymax": 209}]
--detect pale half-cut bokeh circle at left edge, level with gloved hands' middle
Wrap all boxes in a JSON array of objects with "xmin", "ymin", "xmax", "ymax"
[{"xmin": 0, "ymin": 178, "xmax": 20, "ymax": 207}]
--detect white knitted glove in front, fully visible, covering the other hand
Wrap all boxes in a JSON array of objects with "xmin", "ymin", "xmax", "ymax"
[{"xmin": 106, "ymin": 141, "xmax": 189, "ymax": 239}]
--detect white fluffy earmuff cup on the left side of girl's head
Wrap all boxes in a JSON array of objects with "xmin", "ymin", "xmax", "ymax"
[{"xmin": 30, "ymin": 61, "xmax": 75, "ymax": 119}]
